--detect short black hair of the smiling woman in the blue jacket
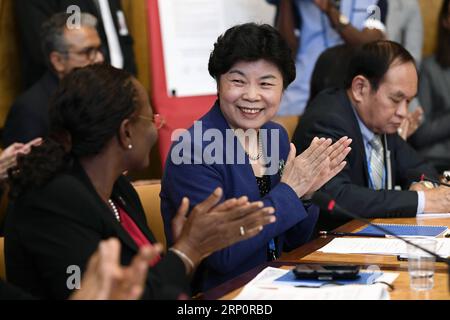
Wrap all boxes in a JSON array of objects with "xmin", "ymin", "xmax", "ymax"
[{"xmin": 208, "ymin": 23, "xmax": 296, "ymax": 89}]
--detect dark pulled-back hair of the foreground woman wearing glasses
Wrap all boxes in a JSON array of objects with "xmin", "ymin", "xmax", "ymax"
[{"xmin": 9, "ymin": 64, "xmax": 138, "ymax": 198}]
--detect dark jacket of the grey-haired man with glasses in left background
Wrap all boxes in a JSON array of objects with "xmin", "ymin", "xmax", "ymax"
[{"xmin": 3, "ymin": 71, "xmax": 58, "ymax": 147}]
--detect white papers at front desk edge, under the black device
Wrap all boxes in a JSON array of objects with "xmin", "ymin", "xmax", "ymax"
[{"xmin": 234, "ymin": 267, "xmax": 398, "ymax": 300}]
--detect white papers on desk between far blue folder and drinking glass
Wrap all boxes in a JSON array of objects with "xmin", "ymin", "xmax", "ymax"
[{"xmin": 318, "ymin": 238, "xmax": 450, "ymax": 257}]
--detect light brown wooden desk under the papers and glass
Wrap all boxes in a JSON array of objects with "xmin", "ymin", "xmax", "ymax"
[{"xmin": 202, "ymin": 216, "xmax": 450, "ymax": 300}]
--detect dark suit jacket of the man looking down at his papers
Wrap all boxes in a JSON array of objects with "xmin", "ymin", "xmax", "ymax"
[{"xmin": 293, "ymin": 89, "xmax": 436, "ymax": 229}]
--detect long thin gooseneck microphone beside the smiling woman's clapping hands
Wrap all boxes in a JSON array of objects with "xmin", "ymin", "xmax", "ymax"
[{"xmin": 311, "ymin": 191, "xmax": 450, "ymax": 291}]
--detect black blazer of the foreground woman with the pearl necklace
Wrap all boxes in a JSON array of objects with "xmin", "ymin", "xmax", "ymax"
[{"xmin": 5, "ymin": 164, "xmax": 189, "ymax": 299}]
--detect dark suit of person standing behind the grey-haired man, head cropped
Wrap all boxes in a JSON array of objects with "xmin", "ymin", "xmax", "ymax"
[{"xmin": 16, "ymin": 0, "xmax": 136, "ymax": 88}]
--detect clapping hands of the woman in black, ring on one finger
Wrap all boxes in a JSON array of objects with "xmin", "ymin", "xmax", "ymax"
[{"xmin": 172, "ymin": 188, "xmax": 276, "ymax": 273}]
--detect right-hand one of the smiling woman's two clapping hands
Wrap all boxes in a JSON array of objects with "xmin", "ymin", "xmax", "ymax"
[{"xmin": 305, "ymin": 137, "xmax": 352, "ymax": 197}]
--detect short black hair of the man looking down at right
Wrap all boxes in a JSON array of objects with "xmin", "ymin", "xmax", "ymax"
[{"xmin": 345, "ymin": 40, "xmax": 416, "ymax": 91}]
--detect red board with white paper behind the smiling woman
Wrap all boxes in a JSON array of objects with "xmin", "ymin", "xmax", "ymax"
[{"xmin": 147, "ymin": 0, "xmax": 275, "ymax": 166}]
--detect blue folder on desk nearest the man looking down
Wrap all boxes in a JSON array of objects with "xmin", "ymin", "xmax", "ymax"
[{"xmin": 356, "ymin": 223, "xmax": 448, "ymax": 237}]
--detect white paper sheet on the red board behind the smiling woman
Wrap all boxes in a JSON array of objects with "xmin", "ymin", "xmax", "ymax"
[{"xmin": 158, "ymin": 0, "xmax": 275, "ymax": 97}]
